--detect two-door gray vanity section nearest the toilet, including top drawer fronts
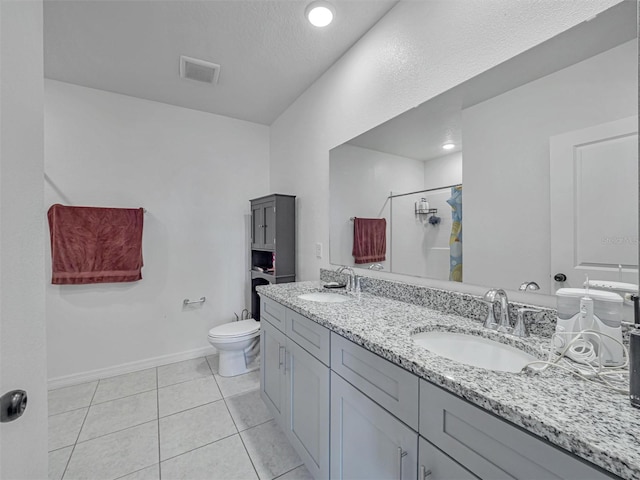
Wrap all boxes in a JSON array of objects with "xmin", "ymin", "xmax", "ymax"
[{"xmin": 260, "ymin": 299, "xmax": 330, "ymax": 480}]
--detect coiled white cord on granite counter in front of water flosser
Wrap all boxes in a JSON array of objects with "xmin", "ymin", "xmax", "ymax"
[{"xmin": 523, "ymin": 329, "xmax": 629, "ymax": 394}]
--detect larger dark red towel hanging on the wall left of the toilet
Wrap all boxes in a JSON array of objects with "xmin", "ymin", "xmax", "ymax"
[{"xmin": 47, "ymin": 204, "xmax": 144, "ymax": 285}]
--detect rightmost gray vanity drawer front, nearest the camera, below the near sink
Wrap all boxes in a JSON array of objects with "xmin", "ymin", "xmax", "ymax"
[{"xmin": 420, "ymin": 380, "xmax": 611, "ymax": 480}]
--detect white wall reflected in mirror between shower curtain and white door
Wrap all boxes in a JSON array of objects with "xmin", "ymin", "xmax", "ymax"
[{"xmin": 462, "ymin": 40, "xmax": 638, "ymax": 292}]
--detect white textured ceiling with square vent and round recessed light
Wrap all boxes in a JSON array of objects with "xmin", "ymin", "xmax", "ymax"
[{"xmin": 44, "ymin": 0, "xmax": 397, "ymax": 125}]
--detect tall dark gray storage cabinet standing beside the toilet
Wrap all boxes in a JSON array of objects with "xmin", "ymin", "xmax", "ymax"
[{"xmin": 250, "ymin": 193, "xmax": 296, "ymax": 320}]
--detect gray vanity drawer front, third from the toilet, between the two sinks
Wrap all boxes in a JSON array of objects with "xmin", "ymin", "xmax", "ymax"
[{"xmin": 331, "ymin": 333, "xmax": 419, "ymax": 429}]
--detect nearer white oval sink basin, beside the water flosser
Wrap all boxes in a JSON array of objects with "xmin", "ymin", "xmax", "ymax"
[{"xmin": 412, "ymin": 331, "xmax": 538, "ymax": 373}]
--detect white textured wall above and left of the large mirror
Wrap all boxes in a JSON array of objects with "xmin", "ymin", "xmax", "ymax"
[{"xmin": 271, "ymin": 0, "xmax": 618, "ymax": 304}]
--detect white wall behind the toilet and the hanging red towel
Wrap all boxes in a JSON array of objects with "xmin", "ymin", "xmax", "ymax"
[{"xmin": 45, "ymin": 80, "xmax": 270, "ymax": 385}]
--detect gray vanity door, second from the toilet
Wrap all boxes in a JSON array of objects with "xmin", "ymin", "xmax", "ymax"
[{"xmin": 285, "ymin": 340, "xmax": 329, "ymax": 480}]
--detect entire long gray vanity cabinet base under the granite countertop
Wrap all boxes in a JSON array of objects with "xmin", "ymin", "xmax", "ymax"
[{"xmin": 261, "ymin": 298, "xmax": 617, "ymax": 480}]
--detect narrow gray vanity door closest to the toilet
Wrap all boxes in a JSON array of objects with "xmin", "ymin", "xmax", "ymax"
[{"xmin": 260, "ymin": 321, "xmax": 286, "ymax": 425}]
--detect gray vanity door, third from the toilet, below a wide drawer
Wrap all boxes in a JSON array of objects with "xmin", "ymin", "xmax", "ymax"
[{"xmin": 331, "ymin": 372, "xmax": 418, "ymax": 480}]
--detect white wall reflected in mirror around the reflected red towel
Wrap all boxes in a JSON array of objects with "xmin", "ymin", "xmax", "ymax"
[{"xmin": 329, "ymin": 145, "xmax": 424, "ymax": 270}]
